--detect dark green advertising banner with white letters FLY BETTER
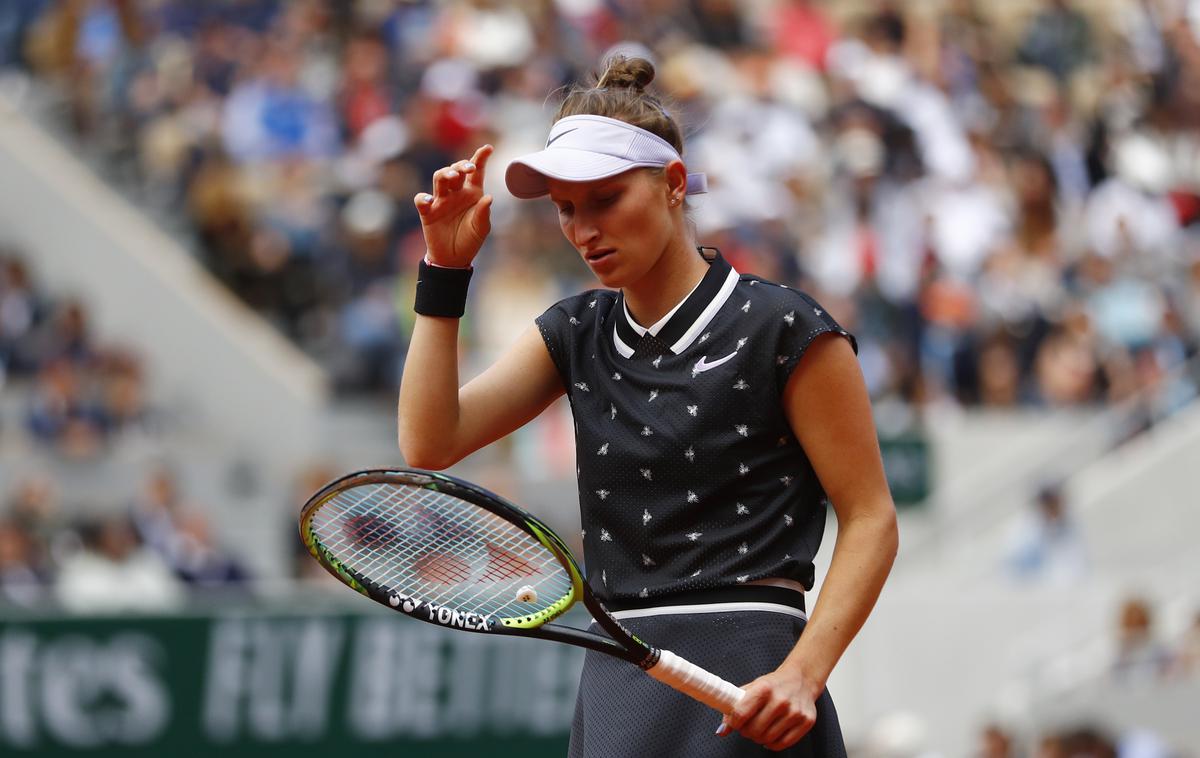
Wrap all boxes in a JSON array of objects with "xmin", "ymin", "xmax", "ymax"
[{"xmin": 0, "ymin": 612, "xmax": 583, "ymax": 758}]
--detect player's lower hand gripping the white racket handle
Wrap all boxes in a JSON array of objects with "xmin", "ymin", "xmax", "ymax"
[{"xmin": 718, "ymin": 670, "xmax": 822, "ymax": 751}]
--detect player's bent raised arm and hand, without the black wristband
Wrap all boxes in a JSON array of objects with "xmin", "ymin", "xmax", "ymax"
[{"xmin": 396, "ymin": 145, "xmax": 563, "ymax": 469}]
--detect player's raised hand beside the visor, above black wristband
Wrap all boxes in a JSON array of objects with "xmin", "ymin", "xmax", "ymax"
[{"xmin": 413, "ymin": 145, "xmax": 494, "ymax": 269}]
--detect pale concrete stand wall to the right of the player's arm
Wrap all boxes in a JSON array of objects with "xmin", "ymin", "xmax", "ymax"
[{"xmin": 822, "ymin": 403, "xmax": 1200, "ymax": 756}]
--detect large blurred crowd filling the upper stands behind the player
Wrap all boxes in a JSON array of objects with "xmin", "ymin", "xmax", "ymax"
[{"xmin": 0, "ymin": 0, "xmax": 1200, "ymax": 419}]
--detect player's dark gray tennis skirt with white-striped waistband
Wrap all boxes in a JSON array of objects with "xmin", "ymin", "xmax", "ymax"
[{"xmin": 568, "ymin": 592, "xmax": 846, "ymax": 758}]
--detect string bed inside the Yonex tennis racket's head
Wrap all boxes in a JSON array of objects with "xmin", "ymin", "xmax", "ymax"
[{"xmin": 312, "ymin": 483, "xmax": 571, "ymax": 616}]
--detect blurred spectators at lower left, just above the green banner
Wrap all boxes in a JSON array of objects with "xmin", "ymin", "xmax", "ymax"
[{"xmin": 0, "ymin": 465, "xmax": 250, "ymax": 614}]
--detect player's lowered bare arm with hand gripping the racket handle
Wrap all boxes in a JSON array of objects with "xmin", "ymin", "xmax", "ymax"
[{"xmin": 722, "ymin": 335, "xmax": 899, "ymax": 750}]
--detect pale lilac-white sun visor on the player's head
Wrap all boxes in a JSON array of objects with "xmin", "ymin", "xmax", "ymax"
[{"xmin": 504, "ymin": 115, "xmax": 708, "ymax": 199}]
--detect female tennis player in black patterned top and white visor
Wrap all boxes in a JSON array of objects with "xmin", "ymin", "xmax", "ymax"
[{"xmin": 398, "ymin": 58, "xmax": 898, "ymax": 758}]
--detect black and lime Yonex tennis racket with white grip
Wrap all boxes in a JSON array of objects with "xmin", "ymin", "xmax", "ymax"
[{"xmin": 300, "ymin": 469, "xmax": 745, "ymax": 714}]
